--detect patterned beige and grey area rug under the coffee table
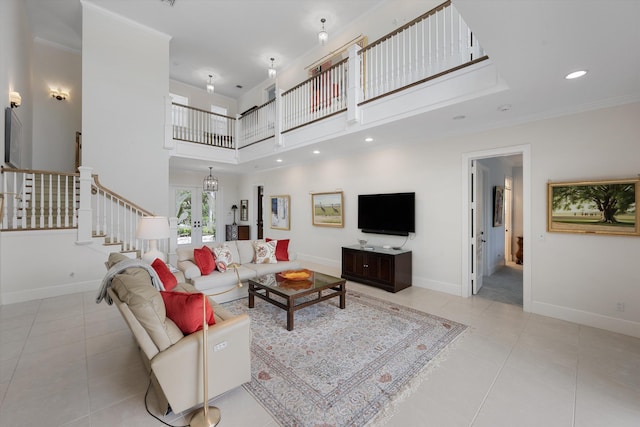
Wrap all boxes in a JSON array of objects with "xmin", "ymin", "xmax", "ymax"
[{"xmin": 224, "ymin": 291, "xmax": 466, "ymax": 427}]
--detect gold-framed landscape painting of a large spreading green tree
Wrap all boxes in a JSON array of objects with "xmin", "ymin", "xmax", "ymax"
[{"xmin": 547, "ymin": 178, "xmax": 640, "ymax": 236}]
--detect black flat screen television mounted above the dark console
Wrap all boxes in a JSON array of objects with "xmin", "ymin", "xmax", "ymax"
[{"xmin": 358, "ymin": 193, "xmax": 416, "ymax": 236}]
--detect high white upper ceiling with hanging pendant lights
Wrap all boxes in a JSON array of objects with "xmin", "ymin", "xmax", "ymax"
[{"xmin": 26, "ymin": 0, "xmax": 390, "ymax": 98}]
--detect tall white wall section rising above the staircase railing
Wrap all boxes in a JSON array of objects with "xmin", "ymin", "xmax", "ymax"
[{"xmin": 82, "ymin": 3, "xmax": 169, "ymax": 215}]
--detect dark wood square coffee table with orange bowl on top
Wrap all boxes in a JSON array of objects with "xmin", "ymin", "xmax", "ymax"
[{"xmin": 249, "ymin": 271, "xmax": 347, "ymax": 331}]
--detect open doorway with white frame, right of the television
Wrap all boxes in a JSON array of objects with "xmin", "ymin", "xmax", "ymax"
[{"xmin": 461, "ymin": 145, "xmax": 531, "ymax": 311}]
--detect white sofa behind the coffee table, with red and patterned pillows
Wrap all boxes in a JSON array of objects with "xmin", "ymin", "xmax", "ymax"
[{"xmin": 176, "ymin": 240, "xmax": 302, "ymax": 303}]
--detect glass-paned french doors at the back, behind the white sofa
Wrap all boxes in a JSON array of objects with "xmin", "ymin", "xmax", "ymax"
[{"xmin": 173, "ymin": 187, "xmax": 216, "ymax": 246}]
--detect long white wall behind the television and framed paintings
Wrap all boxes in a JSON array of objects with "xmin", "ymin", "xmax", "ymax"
[{"xmin": 240, "ymin": 104, "xmax": 640, "ymax": 336}]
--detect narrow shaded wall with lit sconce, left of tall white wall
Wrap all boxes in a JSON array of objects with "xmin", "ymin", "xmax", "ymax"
[{"xmin": 31, "ymin": 39, "xmax": 82, "ymax": 173}]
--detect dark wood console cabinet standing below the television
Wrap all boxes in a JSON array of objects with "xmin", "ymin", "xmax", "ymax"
[{"xmin": 342, "ymin": 245, "xmax": 411, "ymax": 293}]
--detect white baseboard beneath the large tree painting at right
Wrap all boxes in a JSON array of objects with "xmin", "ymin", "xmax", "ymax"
[{"xmin": 531, "ymin": 301, "xmax": 640, "ymax": 338}]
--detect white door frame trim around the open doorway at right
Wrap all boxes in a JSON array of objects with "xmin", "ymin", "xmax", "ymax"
[{"xmin": 460, "ymin": 144, "xmax": 532, "ymax": 312}]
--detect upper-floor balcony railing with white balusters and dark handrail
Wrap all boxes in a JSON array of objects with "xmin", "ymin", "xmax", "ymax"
[{"xmin": 173, "ymin": 1, "xmax": 487, "ymax": 149}]
